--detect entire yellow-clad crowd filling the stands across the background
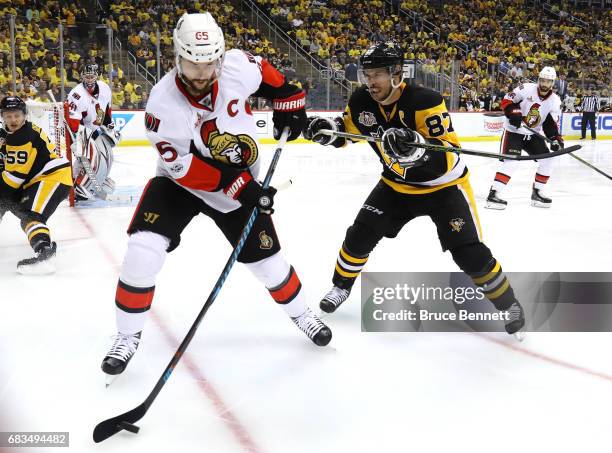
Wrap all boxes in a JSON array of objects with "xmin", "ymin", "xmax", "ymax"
[{"xmin": 0, "ymin": 0, "xmax": 612, "ymax": 111}]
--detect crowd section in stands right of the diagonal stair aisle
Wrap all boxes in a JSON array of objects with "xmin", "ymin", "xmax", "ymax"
[{"xmin": 257, "ymin": 0, "xmax": 612, "ymax": 110}]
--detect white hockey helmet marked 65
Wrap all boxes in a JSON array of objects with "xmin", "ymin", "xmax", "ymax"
[{"xmin": 172, "ymin": 13, "xmax": 225, "ymax": 65}]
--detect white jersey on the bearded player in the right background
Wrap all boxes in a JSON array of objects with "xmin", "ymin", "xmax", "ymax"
[{"xmin": 504, "ymin": 83, "xmax": 561, "ymax": 135}]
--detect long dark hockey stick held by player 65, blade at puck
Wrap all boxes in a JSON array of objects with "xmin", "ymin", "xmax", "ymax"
[{"xmin": 93, "ymin": 128, "xmax": 289, "ymax": 443}]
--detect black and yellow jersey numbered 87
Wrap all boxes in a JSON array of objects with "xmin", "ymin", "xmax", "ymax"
[{"xmin": 334, "ymin": 83, "xmax": 468, "ymax": 194}]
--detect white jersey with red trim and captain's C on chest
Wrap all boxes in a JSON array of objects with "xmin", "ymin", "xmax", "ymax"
[{"xmin": 145, "ymin": 49, "xmax": 267, "ymax": 212}]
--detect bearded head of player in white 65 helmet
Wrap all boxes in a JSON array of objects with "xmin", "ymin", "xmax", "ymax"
[{"xmin": 172, "ymin": 13, "xmax": 225, "ymax": 95}]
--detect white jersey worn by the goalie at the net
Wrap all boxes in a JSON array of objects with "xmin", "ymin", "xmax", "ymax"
[{"xmin": 66, "ymin": 80, "xmax": 112, "ymax": 131}]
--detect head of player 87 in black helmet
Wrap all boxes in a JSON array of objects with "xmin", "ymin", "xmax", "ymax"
[{"xmin": 357, "ymin": 41, "xmax": 404, "ymax": 104}]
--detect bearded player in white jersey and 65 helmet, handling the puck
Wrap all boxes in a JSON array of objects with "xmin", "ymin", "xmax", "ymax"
[{"xmin": 102, "ymin": 13, "xmax": 331, "ymax": 375}]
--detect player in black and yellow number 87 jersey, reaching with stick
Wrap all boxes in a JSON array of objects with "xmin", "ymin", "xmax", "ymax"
[{"xmin": 304, "ymin": 42, "xmax": 525, "ymax": 334}]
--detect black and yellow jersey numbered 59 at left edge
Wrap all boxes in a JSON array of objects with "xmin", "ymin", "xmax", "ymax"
[{"xmin": 0, "ymin": 121, "xmax": 72, "ymax": 189}]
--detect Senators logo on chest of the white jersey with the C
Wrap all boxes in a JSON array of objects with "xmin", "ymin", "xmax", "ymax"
[{"xmin": 200, "ymin": 120, "xmax": 259, "ymax": 167}]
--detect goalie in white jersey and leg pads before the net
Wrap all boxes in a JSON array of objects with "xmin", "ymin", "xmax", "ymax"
[{"xmin": 64, "ymin": 64, "xmax": 121, "ymax": 199}]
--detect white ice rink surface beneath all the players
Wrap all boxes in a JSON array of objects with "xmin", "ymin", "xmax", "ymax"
[{"xmin": 0, "ymin": 141, "xmax": 612, "ymax": 453}]
